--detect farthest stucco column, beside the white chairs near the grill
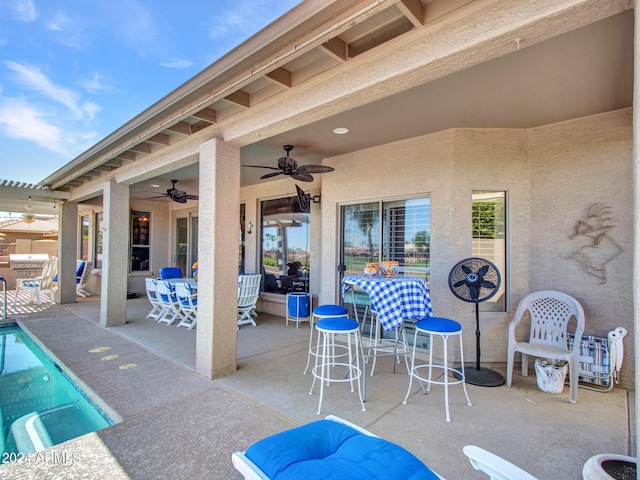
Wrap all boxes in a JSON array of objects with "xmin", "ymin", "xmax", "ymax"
[{"xmin": 55, "ymin": 202, "xmax": 78, "ymax": 303}]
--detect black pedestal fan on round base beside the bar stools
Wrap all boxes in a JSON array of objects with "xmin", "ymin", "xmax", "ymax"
[{"xmin": 449, "ymin": 257, "xmax": 504, "ymax": 387}]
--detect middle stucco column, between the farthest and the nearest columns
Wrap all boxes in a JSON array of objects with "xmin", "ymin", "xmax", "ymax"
[{"xmin": 100, "ymin": 182, "xmax": 129, "ymax": 327}]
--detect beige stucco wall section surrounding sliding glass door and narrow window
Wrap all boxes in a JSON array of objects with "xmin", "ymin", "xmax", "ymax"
[{"xmin": 320, "ymin": 126, "xmax": 529, "ymax": 372}]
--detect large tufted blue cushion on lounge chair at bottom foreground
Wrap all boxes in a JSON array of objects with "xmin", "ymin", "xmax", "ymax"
[{"xmin": 245, "ymin": 420, "xmax": 438, "ymax": 480}]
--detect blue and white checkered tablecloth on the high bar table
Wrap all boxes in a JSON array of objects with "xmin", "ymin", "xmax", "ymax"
[{"xmin": 342, "ymin": 275, "xmax": 433, "ymax": 332}]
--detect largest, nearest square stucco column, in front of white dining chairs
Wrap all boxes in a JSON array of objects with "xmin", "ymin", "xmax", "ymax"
[{"xmin": 196, "ymin": 139, "xmax": 240, "ymax": 378}]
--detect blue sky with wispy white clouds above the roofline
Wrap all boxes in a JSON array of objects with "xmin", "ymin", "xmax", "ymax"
[{"xmin": 0, "ymin": 0, "xmax": 300, "ymax": 183}]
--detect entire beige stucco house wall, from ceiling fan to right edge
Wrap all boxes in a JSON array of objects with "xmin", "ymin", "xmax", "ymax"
[{"xmin": 241, "ymin": 110, "xmax": 634, "ymax": 388}]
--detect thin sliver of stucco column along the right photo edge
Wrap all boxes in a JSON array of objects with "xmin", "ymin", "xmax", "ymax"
[{"xmin": 633, "ymin": 0, "xmax": 640, "ymax": 458}]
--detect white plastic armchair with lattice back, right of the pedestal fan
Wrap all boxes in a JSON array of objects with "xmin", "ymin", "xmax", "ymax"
[{"xmin": 507, "ymin": 290, "xmax": 585, "ymax": 403}]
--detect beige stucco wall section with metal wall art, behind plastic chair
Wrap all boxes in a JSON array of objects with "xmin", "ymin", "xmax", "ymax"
[{"xmin": 529, "ymin": 109, "xmax": 634, "ymax": 388}]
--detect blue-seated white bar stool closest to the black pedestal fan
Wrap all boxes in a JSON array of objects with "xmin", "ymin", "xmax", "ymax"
[{"xmin": 402, "ymin": 317, "xmax": 471, "ymax": 422}]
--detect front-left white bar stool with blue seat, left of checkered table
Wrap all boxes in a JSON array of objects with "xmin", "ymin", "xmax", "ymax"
[{"xmin": 309, "ymin": 317, "xmax": 366, "ymax": 415}]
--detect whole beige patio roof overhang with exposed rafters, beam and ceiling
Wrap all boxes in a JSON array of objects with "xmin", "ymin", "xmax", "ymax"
[{"xmin": 28, "ymin": 0, "xmax": 633, "ymax": 202}]
